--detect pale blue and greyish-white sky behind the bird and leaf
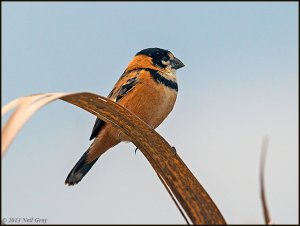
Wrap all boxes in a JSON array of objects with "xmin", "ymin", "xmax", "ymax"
[{"xmin": 1, "ymin": 2, "xmax": 299, "ymax": 224}]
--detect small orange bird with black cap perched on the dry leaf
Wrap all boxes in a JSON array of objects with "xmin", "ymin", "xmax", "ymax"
[{"xmin": 65, "ymin": 48, "xmax": 185, "ymax": 186}]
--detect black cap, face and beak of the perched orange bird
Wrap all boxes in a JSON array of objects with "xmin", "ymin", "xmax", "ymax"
[{"xmin": 136, "ymin": 48, "xmax": 184, "ymax": 69}]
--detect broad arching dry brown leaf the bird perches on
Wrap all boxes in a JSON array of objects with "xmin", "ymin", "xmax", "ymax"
[{"xmin": 2, "ymin": 93, "xmax": 225, "ymax": 224}]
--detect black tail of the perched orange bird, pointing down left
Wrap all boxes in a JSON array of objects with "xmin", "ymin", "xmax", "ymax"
[{"xmin": 65, "ymin": 149, "xmax": 99, "ymax": 185}]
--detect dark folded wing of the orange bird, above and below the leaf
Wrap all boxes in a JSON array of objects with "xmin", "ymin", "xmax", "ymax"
[{"xmin": 90, "ymin": 77, "xmax": 137, "ymax": 140}]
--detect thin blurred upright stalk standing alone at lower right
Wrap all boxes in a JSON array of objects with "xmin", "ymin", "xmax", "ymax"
[{"xmin": 259, "ymin": 137, "xmax": 272, "ymax": 224}]
